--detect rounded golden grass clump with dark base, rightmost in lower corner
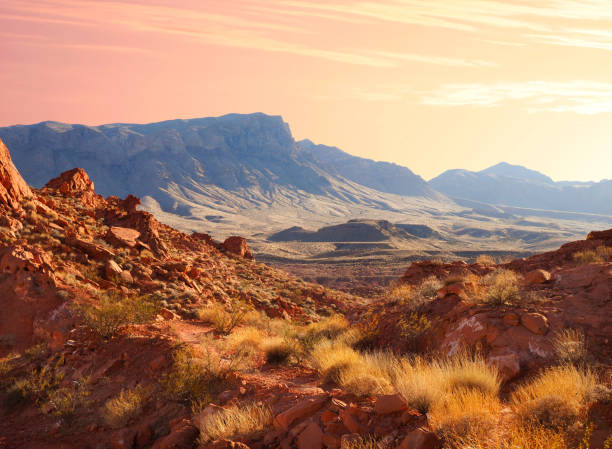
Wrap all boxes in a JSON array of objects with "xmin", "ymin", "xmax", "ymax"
[{"xmin": 512, "ymin": 365, "xmax": 600, "ymax": 429}]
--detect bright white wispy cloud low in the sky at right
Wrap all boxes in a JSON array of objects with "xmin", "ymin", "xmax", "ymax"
[{"xmin": 421, "ymin": 80, "xmax": 612, "ymax": 115}]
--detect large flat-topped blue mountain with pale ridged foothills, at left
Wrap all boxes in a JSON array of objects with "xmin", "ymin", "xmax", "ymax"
[{"xmin": 0, "ymin": 114, "xmax": 457, "ymax": 238}]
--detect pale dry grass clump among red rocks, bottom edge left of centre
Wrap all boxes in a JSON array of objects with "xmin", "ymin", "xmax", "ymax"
[{"xmin": 200, "ymin": 404, "xmax": 273, "ymax": 443}]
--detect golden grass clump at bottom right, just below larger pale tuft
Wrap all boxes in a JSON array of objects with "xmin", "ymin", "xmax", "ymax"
[{"xmin": 428, "ymin": 389, "xmax": 501, "ymax": 441}]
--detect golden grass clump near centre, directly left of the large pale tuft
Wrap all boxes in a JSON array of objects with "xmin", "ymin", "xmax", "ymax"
[{"xmin": 310, "ymin": 340, "xmax": 395, "ymax": 395}]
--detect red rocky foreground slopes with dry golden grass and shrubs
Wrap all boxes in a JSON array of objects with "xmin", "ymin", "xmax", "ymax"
[{"xmin": 0, "ymin": 137, "xmax": 612, "ymax": 449}]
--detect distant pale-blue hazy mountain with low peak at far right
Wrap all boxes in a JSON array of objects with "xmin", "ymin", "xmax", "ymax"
[{"xmin": 429, "ymin": 163, "xmax": 612, "ymax": 214}]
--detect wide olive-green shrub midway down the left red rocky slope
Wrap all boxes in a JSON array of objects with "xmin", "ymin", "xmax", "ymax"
[{"xmin": 74, "ymin": 293, "xmax": 158, "ymax": 339}]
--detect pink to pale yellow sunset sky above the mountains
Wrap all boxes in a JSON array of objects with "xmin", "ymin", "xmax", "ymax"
[{"xmin": 0, "ymin": 0, "xmax": 612, "ymax": 181}]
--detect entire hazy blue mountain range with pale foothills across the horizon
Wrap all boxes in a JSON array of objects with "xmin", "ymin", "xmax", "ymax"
[{"xmin": 0, "ymin": 113, "xmax": 612, "ymax": 249}]
